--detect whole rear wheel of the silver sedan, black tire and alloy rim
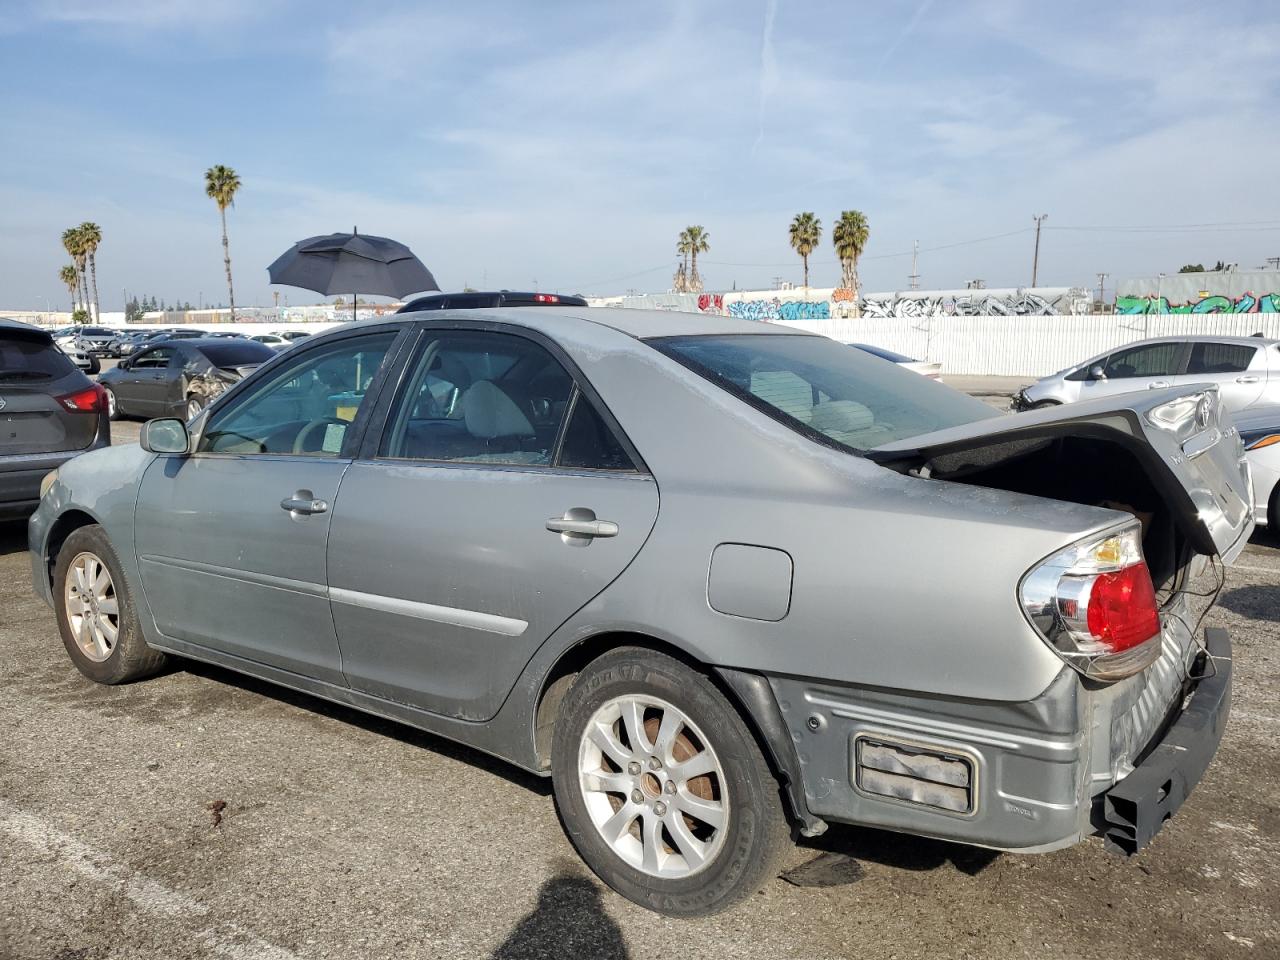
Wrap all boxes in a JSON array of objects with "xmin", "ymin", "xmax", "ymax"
[{"xmin": 552, "ymin": 648, "xmax": 790, "ymax": 916}]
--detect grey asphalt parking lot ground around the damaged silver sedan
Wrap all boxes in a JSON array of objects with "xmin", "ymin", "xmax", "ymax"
[{"xmin": 0, "ymin": 384, "xmax": 1280, "ymax": 960}]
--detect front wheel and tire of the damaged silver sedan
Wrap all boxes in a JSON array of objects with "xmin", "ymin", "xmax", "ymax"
[{"xmin": 54, "ymin": 524, "xmax": 166, "ymax": 684}]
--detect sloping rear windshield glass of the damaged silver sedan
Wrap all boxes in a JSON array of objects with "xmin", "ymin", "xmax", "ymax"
[{"xmin": 649, "ymin": 334, "xmax": 998, "ymax": 452}]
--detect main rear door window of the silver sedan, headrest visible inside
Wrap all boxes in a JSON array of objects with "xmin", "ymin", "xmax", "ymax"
[{"xmin": 379, "ymin": 330, "xmax": 573, "ymax": 466}]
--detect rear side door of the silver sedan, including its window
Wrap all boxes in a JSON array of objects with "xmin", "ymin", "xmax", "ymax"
[{"xmin": 329, "ymin": 330, "xmax": 658, "ymax": 721}]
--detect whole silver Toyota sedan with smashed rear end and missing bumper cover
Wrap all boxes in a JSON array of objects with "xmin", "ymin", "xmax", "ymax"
[{"xmin": 29, "ymin": 306, "xmax": 1253, "ymax": 916}]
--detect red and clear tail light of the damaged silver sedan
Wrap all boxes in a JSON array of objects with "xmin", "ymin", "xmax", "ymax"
[{"xmin": 1019, "ymin": 522, "xmax": 1161, "ymax": 680}]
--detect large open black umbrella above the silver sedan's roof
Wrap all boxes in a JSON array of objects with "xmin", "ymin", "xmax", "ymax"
[{"xmin": 266, "ymin": 229, "xmax": 440, "ymax": 319}]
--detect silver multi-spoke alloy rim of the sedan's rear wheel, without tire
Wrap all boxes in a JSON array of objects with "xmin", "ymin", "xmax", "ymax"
[{"xmin": 577, "ymin": 695, "xmax": 730, "ymax": 879}]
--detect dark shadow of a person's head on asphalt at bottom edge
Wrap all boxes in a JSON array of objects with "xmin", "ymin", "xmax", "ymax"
[{"xmin": 489, "ymin": 869, "xmax": 630, "ymax": 960}]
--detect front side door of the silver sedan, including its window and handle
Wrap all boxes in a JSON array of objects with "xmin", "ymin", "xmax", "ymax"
[{"xmin": 136, "ymin": 328, "xmax": 397, "ymax": 685}]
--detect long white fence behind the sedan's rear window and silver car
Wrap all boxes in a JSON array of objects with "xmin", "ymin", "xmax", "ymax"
[{"xmin": 780, "ymin": 314, "xmax": 1280, "ymax": 376}]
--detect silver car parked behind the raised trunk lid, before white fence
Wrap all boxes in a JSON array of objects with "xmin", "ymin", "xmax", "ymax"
[{"xmin": 1010, "ymin": 337, "xmax": 1280, "ymax": 412}]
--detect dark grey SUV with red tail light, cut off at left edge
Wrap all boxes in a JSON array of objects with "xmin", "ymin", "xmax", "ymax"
[{"xmin": 0, "ymin": 317, "xmax": 111, "ymax": 520}]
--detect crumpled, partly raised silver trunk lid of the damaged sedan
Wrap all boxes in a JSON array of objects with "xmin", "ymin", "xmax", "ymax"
[{"xmin": 867, "ymin": 384, "xmax": 1253, "ymax": 562}]
